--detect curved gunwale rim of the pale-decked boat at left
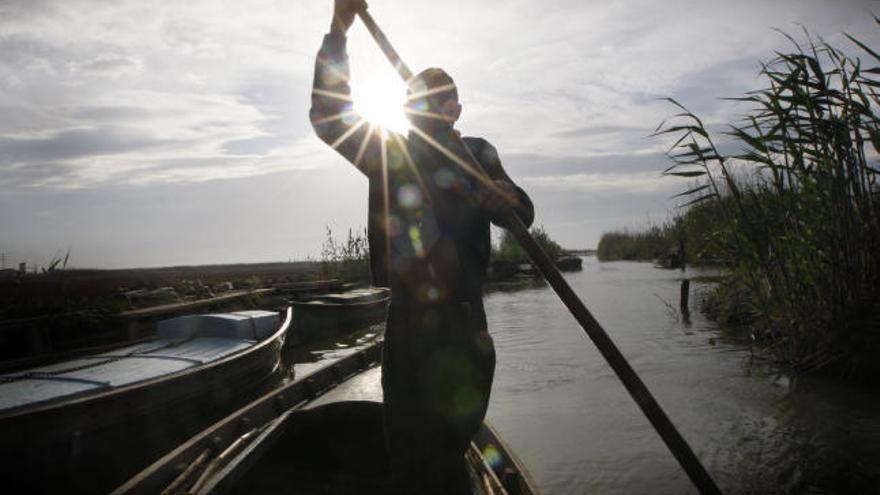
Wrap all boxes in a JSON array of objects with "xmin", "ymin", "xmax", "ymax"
[{"xmin": 0, "ymin": 306, "xmax": 293, "ymax": 421}]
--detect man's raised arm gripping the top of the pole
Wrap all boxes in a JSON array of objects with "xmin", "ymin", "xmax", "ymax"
[{"xmin": 309, "ymin": 0, "xmax": 379, "ymax": 173}]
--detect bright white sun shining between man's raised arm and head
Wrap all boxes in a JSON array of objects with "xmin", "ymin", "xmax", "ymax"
[{"xmin": 351, "ymin": 67, "xmax": 409, "ymax": 134}]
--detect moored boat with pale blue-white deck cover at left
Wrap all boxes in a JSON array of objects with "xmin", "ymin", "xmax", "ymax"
[{"xmin": 0, "ymin": 308, "xmax": 292, "ymax": 493}]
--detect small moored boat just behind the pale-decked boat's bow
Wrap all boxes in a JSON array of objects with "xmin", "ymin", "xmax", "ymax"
[{"xmin": 288, "ymin": 287, "xmax": 391, "ymax": 344}]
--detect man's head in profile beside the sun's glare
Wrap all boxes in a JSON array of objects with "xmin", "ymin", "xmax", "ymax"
[{"xmin": 406, "ymin": 68, "xmax": 461, "ymax": 131}]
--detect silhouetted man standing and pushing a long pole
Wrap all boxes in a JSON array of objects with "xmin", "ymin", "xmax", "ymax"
[{"xmin": 310, "ymin": 0, "xmax": 534, "ymax": 495}]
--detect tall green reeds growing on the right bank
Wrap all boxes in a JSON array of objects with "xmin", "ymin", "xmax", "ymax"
[{"xmin": 600, "ymin": 27, "xmax": 880, "ymax": 381}]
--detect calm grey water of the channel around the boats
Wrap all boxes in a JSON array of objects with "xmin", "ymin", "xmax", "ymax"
[{"xmin": 286, "ymin": 257, "xmax": 880, "ymax": 495}]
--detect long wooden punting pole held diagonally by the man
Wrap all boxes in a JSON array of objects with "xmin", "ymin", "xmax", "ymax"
[{"xmin": 358, "ymin": 10, "xmax": 721, "ymax": 494}]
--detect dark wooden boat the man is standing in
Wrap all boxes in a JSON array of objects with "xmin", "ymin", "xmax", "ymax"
[{"xmin": 112, "ymin": 343, "xmax": 539, "ymax": 495}]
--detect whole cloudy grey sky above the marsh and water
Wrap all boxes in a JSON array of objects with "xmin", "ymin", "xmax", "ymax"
[{"xmin": 0, "ymin": 0, "xmax": 880, "ymax": 268}]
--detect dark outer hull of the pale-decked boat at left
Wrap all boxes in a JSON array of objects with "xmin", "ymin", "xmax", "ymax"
[{"xmin": 0, "ymin": 312, "xmax": 290, "ymax": 493}]
